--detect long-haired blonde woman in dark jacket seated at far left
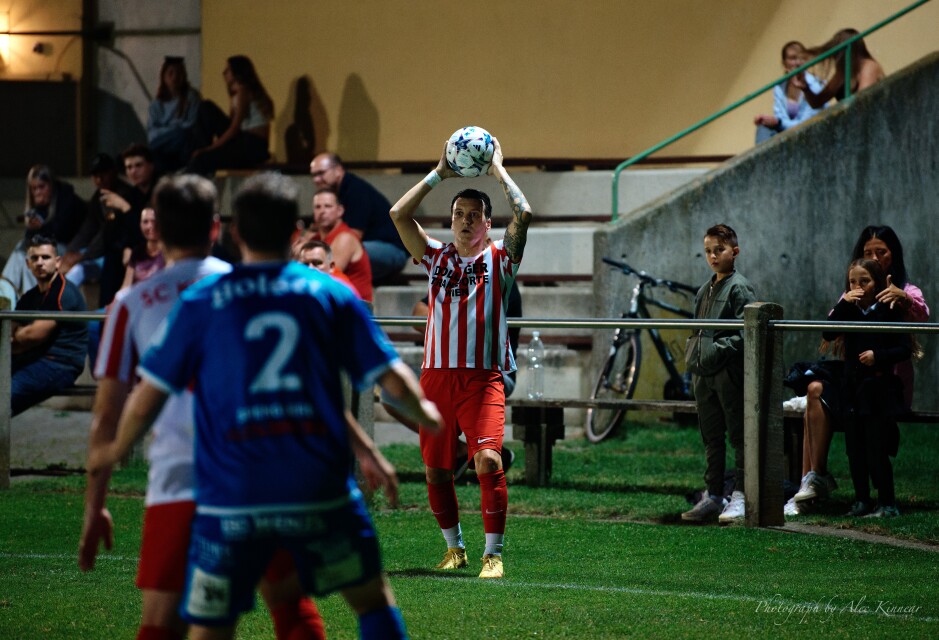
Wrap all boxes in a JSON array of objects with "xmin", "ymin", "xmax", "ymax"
[{"xmin": 3, "ymin": 164, "xmax": 87, "ymax": 294}]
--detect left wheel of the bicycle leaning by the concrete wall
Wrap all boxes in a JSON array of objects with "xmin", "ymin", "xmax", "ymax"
[{"xmin": 587, "ymin": 331, "xmax": 642, "ymax": 442}]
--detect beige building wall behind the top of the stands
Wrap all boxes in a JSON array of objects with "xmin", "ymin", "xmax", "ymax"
[{"xmin": 202, "ymin": 0, "xmax": 939, "ymax": 160}]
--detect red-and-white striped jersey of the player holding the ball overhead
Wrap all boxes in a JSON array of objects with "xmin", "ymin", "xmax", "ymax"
[{"xmin": 421, "ymin": 238, "xmax": 519, "ymax": 371}]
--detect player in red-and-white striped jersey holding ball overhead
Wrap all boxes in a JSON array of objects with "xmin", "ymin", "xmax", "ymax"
[{"xmin": 391, "ymin": 132, "xmax": 532, "ymax": 578}]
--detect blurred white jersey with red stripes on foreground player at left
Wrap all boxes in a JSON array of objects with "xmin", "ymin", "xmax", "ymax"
[{"xmin": 95, "ymin": 258, "xmax": 231, "ymax": 505}]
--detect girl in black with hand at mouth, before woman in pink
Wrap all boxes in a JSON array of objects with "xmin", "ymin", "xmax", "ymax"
[{"xmin": 822, "ymin": 258, "xmax": 912, "ymax": 518}]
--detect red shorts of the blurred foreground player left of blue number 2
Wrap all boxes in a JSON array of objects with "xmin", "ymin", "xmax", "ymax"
[{"xmin": 137, "ymin": 500, "xmax": 196, "ymax": 593}]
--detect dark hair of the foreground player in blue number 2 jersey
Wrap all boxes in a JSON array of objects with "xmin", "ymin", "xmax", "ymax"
[{"xmin": 232, "ymin": 173, "xmax": 300, "ymax": 256}]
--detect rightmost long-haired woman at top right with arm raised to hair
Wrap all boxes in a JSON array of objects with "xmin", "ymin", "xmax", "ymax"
[{"xmin": 792, "ymin": 29, "xmax": 885, "ymax": 109}]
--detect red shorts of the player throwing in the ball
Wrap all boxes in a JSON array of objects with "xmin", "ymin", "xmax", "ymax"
[{"xmin": 420, "ymin": 369, "xmax": 505, "ymax": 469}]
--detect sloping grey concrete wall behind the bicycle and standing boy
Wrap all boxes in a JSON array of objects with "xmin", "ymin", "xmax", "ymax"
[{"xmin": 594, "ymin": 53, "xmax": 939, "ymax": 409}]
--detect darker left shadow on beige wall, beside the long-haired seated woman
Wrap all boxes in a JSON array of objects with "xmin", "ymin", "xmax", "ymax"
[{"xmin": 277, "ymin": 76, "xmax": 329, "ymax": 165}]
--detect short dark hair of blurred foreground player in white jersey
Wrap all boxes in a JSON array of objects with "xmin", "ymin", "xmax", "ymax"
[{"xmin": 153, "ymin": 174, "xmax": 218, "ymax": 247}]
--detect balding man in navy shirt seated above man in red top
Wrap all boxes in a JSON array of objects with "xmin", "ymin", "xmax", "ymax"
[{"xmin": 310, "ymin": 153, "xmax": 409, "ymax": 284}]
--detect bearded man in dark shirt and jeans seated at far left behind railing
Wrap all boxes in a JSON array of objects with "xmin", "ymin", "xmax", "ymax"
[{"xmin": 10, "ymin": 235, "xmax": 88, "ymax": 415}]
